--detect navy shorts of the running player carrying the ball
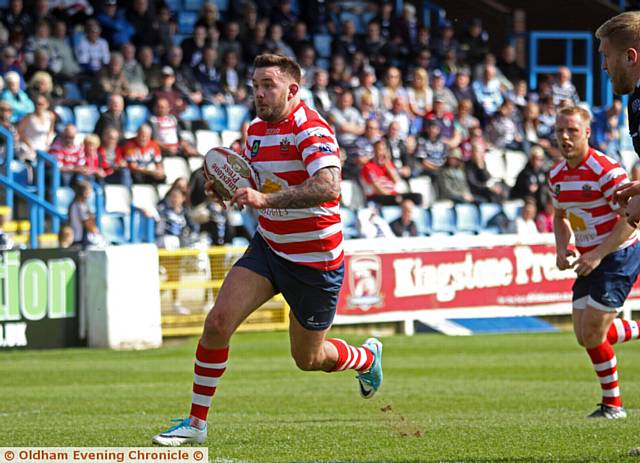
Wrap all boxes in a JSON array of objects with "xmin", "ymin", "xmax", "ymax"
[{"xmin": 235, "ymin": 232, "xmax": 344, "ymax": 331}]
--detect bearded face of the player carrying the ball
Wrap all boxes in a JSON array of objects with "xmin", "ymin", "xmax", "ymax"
[{"xmin": 253, "ymin": 67, "xmax": 297, "ymax": 122}]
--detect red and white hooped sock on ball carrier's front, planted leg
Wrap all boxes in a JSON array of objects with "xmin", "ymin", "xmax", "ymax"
[{"xmin": 190, "ymin": 343, "xmax": 229, "ymax": 427}]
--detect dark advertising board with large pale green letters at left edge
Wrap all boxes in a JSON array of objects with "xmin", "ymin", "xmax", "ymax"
[{"xmin": 0, "ymin": 249, "xmax": 82, "ymax": 349}]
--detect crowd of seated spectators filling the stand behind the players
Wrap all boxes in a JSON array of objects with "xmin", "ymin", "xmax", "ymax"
[{"xmin": 0, "ymin": 0, "xmax": 622, "ymax": 246}]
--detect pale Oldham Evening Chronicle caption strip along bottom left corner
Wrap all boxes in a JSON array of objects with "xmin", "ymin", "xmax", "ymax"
[{"xmin": 0, "ymin": 447, "xmax": 209, "ymax": 463}]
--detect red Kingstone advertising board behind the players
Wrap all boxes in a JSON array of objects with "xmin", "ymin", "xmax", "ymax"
[{"xmin": 338, "ymin": 244, "xmax": 640, "ymax": 315}]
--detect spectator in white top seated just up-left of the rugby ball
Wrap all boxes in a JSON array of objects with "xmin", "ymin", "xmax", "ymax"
[{"xmin": 149, "ymin": 98, "xmax": 199, "ymax": 157}]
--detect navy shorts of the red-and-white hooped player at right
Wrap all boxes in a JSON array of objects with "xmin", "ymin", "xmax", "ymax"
[{"xmin": 573, "ymin": 242, "xmax": 640, "ymax": 312}]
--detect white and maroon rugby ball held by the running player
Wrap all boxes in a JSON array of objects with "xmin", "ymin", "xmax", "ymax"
[{"xmin": 203, "ymin": 147, "xmax": 258, "ymax": 201}]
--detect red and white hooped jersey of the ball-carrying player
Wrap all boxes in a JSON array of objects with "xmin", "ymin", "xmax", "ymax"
[{"xmin": 244, "ymin": 102, "xmax": 344, "ymax": 271}]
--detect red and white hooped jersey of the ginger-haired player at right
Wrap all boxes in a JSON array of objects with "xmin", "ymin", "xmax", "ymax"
[{"xmin": 549, "ymin": 148, "xmax": 638, "ymax": 253}]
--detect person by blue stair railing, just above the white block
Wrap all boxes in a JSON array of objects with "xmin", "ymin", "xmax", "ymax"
[{"xmin": 69, "ymin": 180, "xmax": 105, "ymax": 248}]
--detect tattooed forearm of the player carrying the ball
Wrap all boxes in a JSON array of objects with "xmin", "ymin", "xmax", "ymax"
[{"xmin": 267, "ymin": 166, "xmax": 340, "ymax": 209}]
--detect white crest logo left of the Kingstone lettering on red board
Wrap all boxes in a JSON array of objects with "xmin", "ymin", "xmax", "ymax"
[{"xmin": 347, "ymin": 256, "xmax": 384, "ymax": 310}]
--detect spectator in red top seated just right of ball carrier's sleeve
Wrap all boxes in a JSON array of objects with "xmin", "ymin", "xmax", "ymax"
[{"xmin": 360, "ymin": 140, "xmax": 400, "ymax": 206}]
